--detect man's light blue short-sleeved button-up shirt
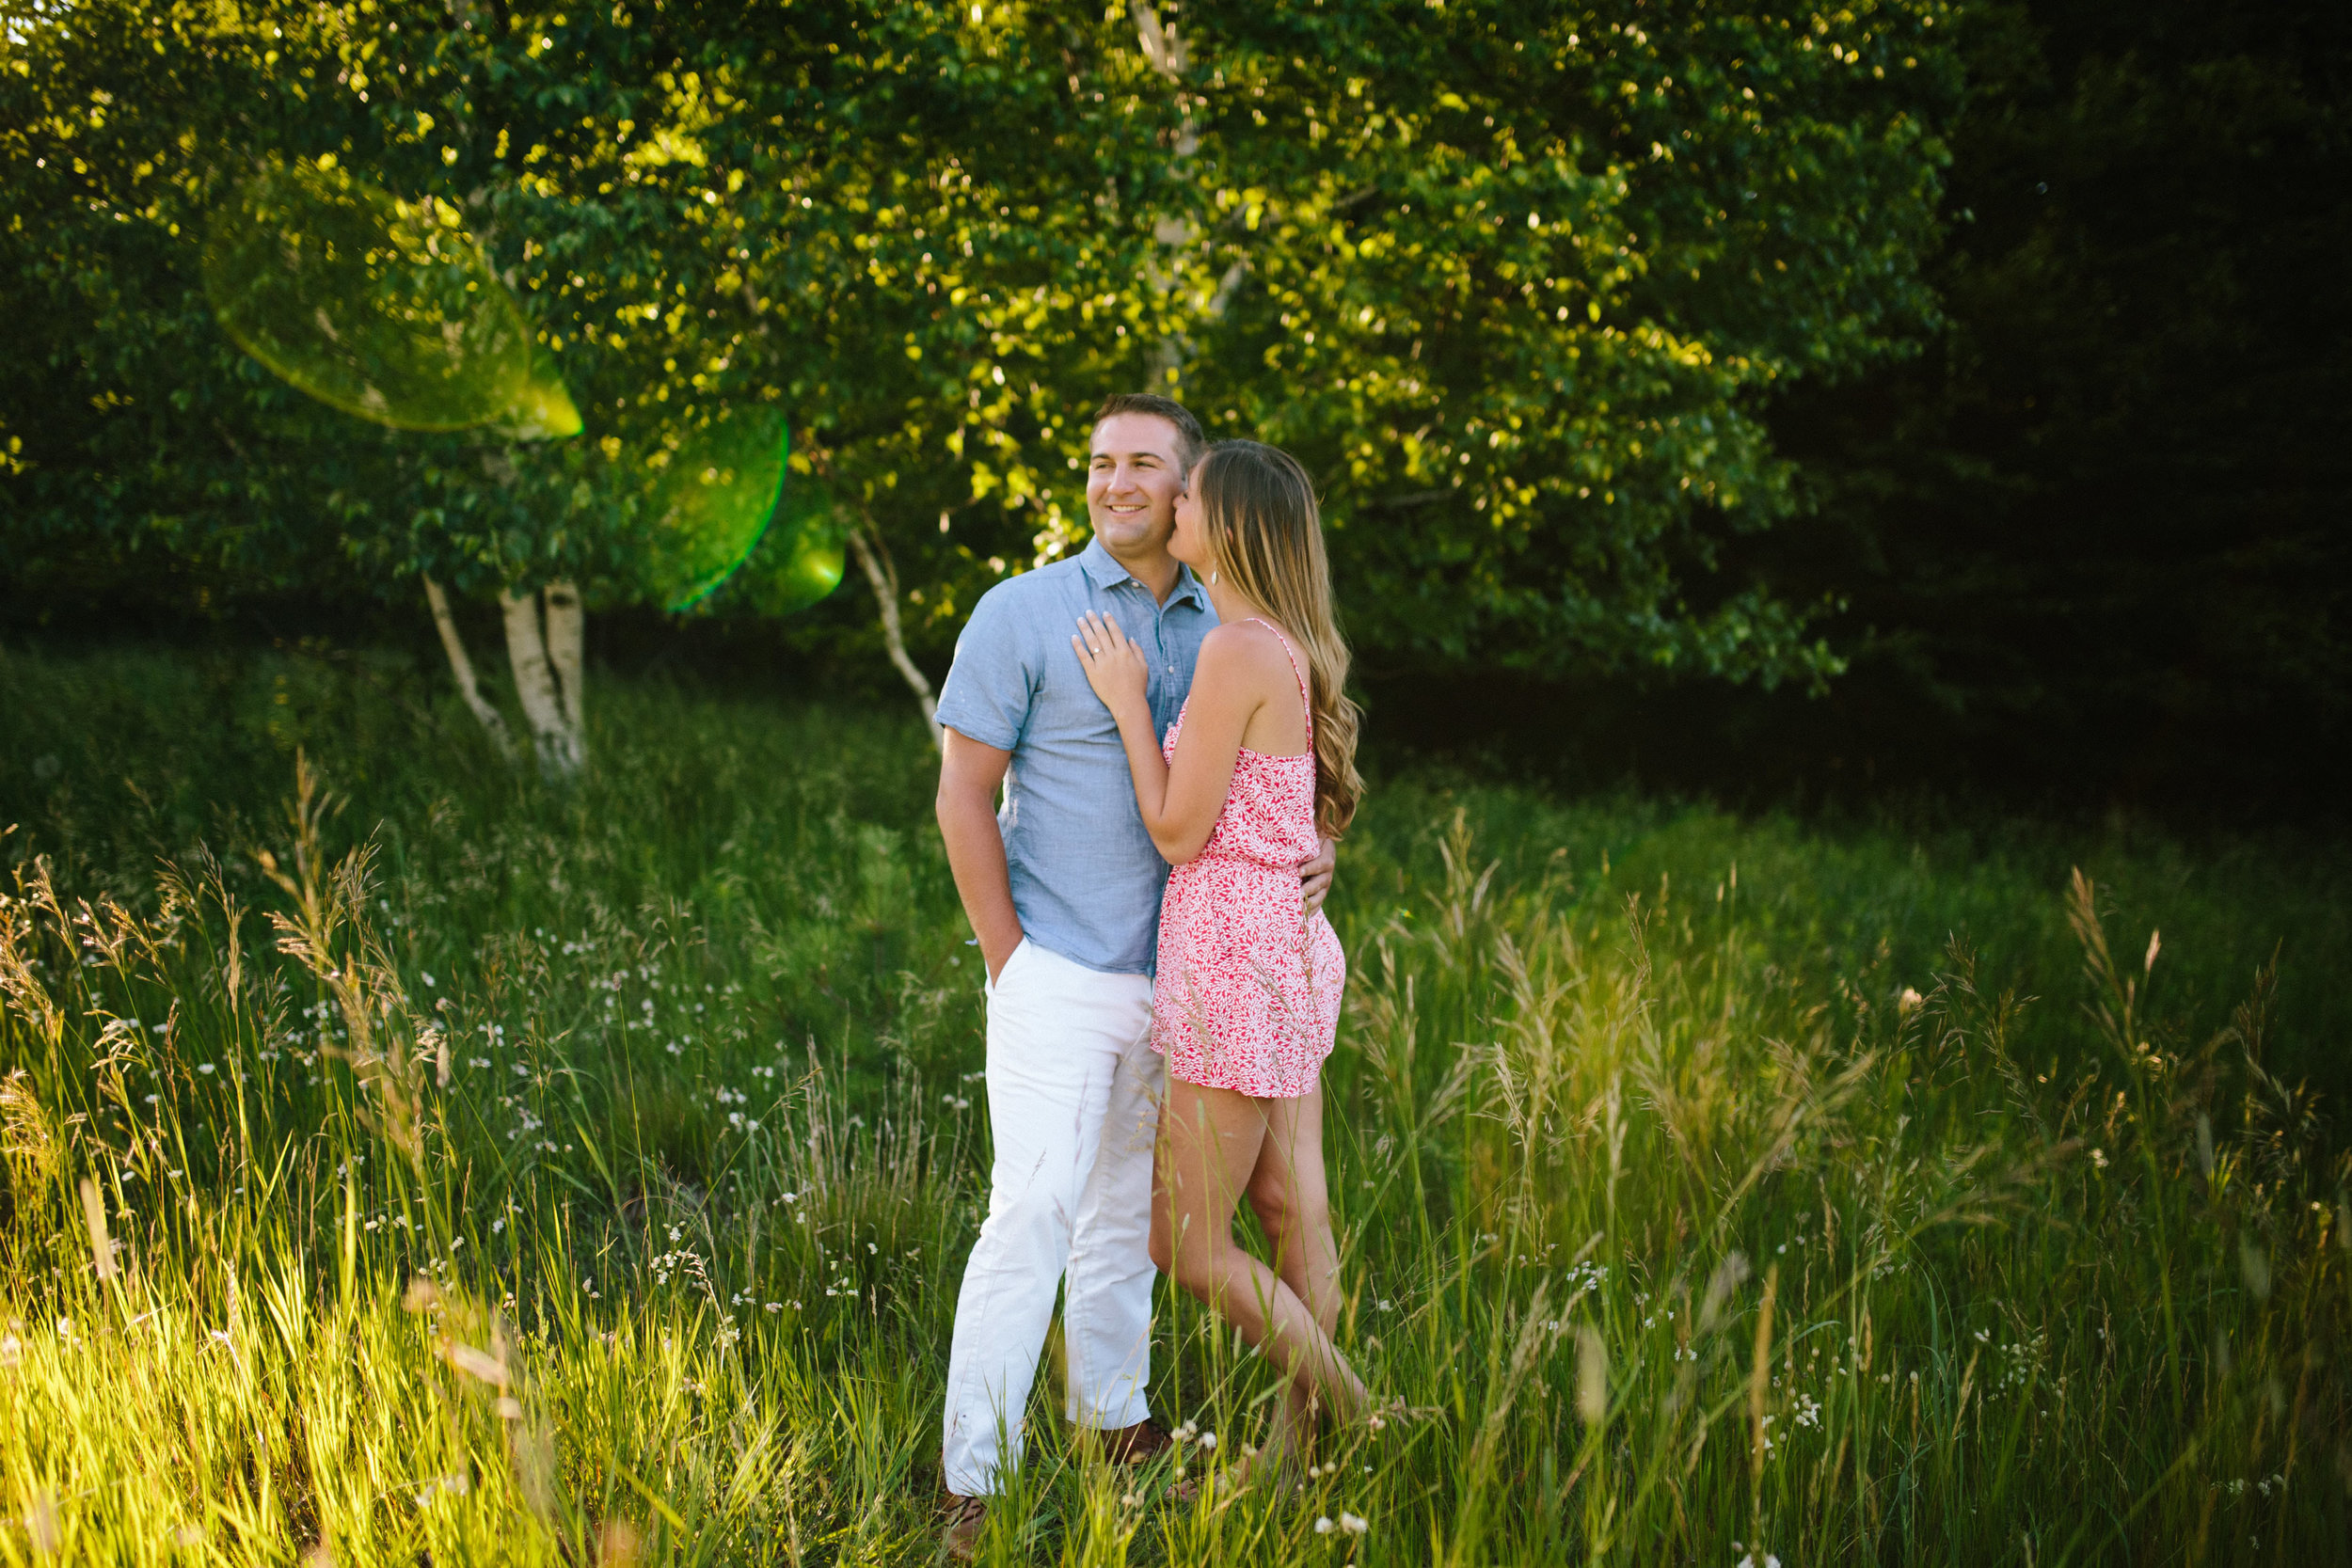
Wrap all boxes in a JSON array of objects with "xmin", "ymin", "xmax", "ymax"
[{"xmin": 939, "ymin": 541, "xmax": 1216, "ymax": 975}]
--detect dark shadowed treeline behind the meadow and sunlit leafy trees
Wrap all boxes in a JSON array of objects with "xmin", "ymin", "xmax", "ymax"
[{"xmin": 0, "ymin": 0, "xmax": 2352, "ymax": 818}]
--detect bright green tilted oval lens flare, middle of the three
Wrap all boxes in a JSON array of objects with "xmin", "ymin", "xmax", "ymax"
[{"xmin": 654, "ymin": 409, "xmax": 793, "ymax": 611}]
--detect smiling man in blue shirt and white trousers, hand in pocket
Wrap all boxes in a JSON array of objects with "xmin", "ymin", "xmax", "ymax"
[{"xmin": 939, "ymin": 395, "xmax": 1331, "ymax": 1559}]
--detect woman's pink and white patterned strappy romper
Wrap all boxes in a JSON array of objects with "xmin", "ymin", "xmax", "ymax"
[{"xmin": 1152, "ymin": 616, "xmax": 1348, "ymax": 1101}]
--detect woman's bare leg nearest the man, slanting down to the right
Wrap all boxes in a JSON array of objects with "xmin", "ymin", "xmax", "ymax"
[{"xmin": 1152, "ymin": 1079, "xmax": 1367, "ymax": 1418}]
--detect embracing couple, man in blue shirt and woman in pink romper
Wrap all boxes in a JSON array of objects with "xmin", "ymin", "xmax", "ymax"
[{"xmin": 939, "ymin": 395, "xmax": 1367, "ymax": 1557}]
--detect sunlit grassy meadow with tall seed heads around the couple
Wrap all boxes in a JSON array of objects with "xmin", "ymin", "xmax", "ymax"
[{"xmin": 0, "ymin": 651, "xmax": 2352, "ymax": 1568}]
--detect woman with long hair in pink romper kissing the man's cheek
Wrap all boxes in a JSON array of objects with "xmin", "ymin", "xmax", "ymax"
[{"xmin": 1073, "ymin": 442, "xmax": 1367, "ymax": 1463}]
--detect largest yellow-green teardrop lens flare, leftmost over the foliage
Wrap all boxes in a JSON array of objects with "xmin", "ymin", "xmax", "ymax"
[{"xmin": 202, "ymin": 162, "xmax": 581, "ymax": 439}]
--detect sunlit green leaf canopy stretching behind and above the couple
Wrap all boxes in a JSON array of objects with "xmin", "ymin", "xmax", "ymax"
[{"xmin": 0, "ymin": 0, "xmax": 1950, "ymax": 679}]
